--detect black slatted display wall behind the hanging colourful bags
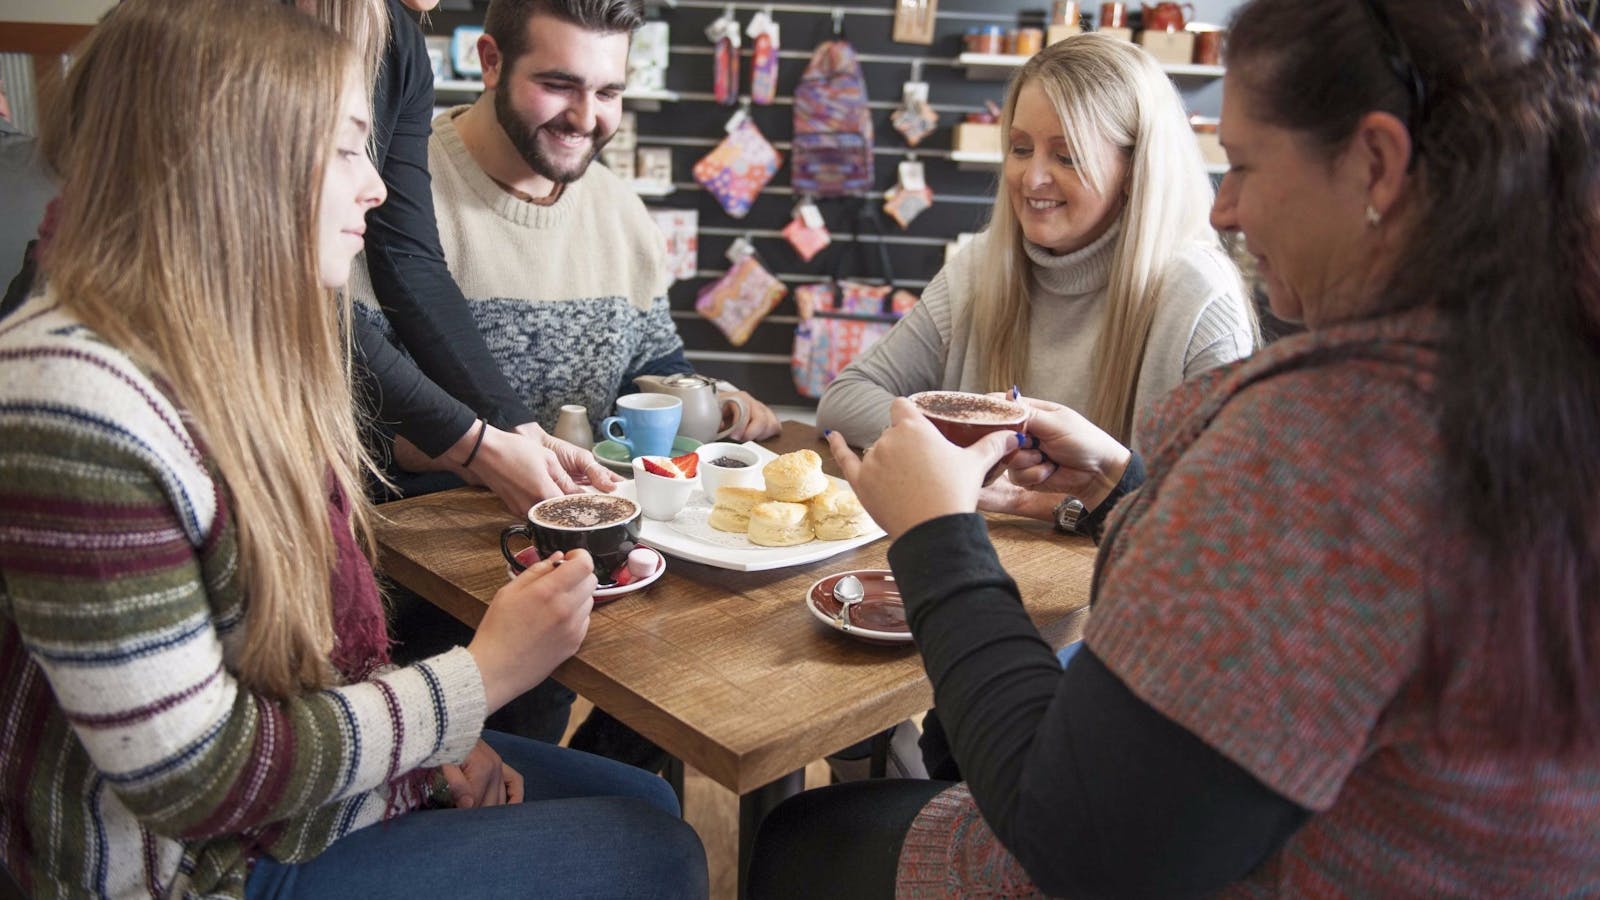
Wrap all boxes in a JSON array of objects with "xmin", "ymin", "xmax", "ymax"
[{"xmin": 427, "ymin": 0, "xmax": 1237, "ymax": 405}]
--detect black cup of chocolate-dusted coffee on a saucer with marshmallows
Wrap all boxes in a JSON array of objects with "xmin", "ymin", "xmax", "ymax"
[{"xmin": 501, "ymin": 493, "xmax": 638, "ymax": 585}]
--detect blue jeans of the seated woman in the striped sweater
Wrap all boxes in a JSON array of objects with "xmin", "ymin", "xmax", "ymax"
[{"xmin": 245, "ymin": 732, "xmax": 709, "ymax": 900}]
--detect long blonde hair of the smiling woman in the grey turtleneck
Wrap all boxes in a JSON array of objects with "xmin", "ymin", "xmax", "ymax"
[{"xmin": 971, "ymin": 34, "xmax": 1242, "ymax": 442}]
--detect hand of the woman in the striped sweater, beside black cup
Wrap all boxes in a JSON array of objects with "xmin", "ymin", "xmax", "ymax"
[{"xmin": 467, "ymin": 549, "xmax": 598, "ymax": 713}]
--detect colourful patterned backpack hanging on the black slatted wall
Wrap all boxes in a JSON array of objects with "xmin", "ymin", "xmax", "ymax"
[{"xmin": 790, "ymin": 40, "xmax": 872, "ymax": 197}]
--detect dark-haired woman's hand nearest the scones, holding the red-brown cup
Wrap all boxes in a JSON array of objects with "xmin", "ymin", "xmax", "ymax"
[{"xmin": 827, "ymin": 397, "xmax": 1018, "ymax": 540}]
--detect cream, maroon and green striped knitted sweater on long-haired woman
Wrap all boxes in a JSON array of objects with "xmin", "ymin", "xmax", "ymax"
[{"xmin": 0, "ymin": 295, "xmax": 485, "ymax": 897}]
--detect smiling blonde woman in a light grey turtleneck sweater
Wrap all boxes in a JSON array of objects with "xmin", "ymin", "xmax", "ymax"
[{"xmin": 818, "ymin": 34, "xmax": 1256, "ymax": 519}]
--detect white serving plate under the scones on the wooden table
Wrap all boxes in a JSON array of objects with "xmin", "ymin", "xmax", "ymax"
[{"xmin": 616, "ymin": 442, "xmax": 885, "ymax": 572}]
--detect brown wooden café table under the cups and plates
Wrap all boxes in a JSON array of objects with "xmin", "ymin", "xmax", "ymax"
[{"xmin": 378, "ymin": 421, "xmax": 1094, "ymax": 882}]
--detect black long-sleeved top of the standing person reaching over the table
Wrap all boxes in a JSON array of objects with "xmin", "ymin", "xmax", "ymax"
[{"xmin": 352, "ymin": 0, "xmax": 534, "ymax": 456}]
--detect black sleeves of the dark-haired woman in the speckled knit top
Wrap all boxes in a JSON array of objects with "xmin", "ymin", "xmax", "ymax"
[{"xmin": 888, "ymin": 466, "xmax": 1310, "ymax": 897}]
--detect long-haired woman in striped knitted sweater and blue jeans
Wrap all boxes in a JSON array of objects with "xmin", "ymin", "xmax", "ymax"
[{"xmin": 0, "ymin": 0, "xmax": 706, "ymax": 897}]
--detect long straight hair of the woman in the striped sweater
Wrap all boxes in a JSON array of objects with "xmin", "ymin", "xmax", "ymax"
[{"xmin": 43, "ymin": 0, "xmax": 380, "ymax": 698}]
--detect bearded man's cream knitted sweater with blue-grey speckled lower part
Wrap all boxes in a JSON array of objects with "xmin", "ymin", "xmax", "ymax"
[{"xmin": 350, "ymin": 107, "xmax": 691, "ymax": 431}]
